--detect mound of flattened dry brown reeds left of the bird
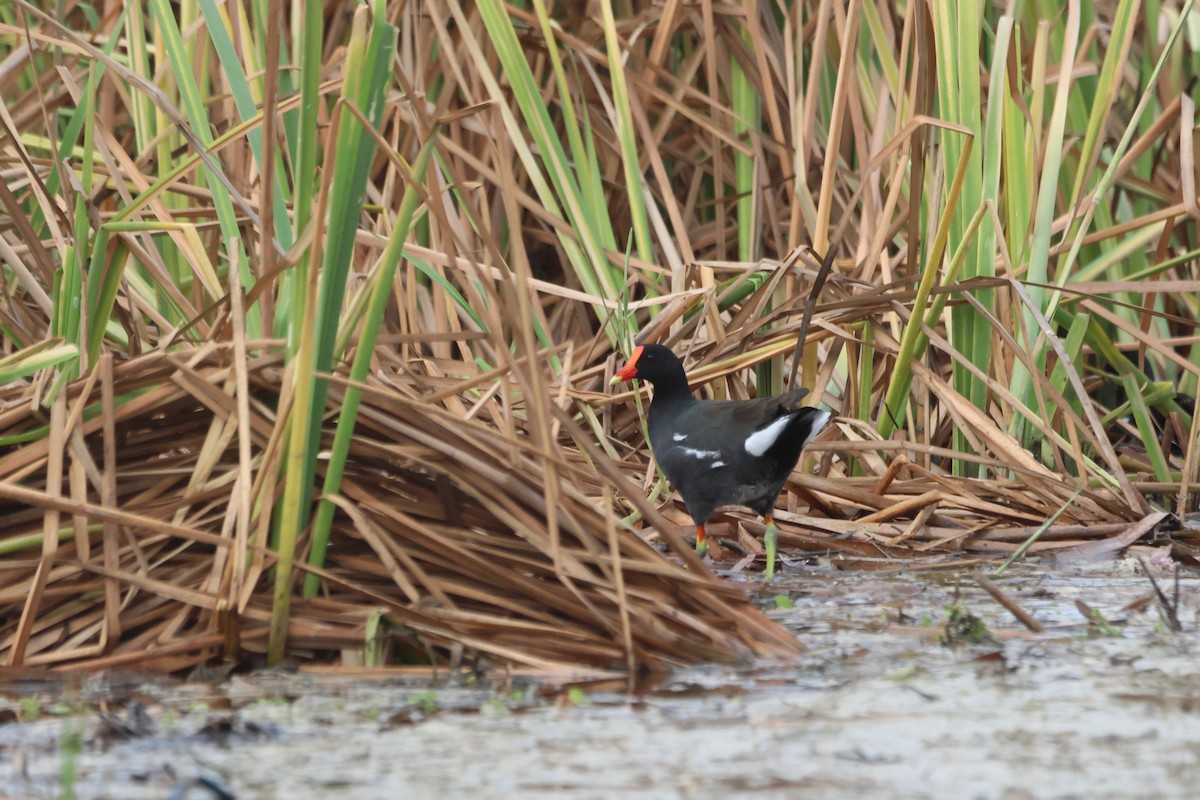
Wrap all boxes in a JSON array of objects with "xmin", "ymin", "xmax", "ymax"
[{"xmin": 0, "ymin": 343, "xmax": 794, "ymax": 672}]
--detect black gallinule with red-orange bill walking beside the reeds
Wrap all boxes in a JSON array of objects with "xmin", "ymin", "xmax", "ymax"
[{"xmin": 611, "ymin": 344, "xmax": 830, "ymax": 581}]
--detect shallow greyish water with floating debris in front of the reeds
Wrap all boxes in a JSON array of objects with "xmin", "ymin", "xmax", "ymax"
[{"xmin": 0, "ymin": 561, "xmax": 1200, "ymax": 800}]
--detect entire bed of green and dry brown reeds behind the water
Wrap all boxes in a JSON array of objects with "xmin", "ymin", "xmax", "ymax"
[{"xmin": 0, "ymin": 0, "xmax": 1200, "ymax": 672}]
